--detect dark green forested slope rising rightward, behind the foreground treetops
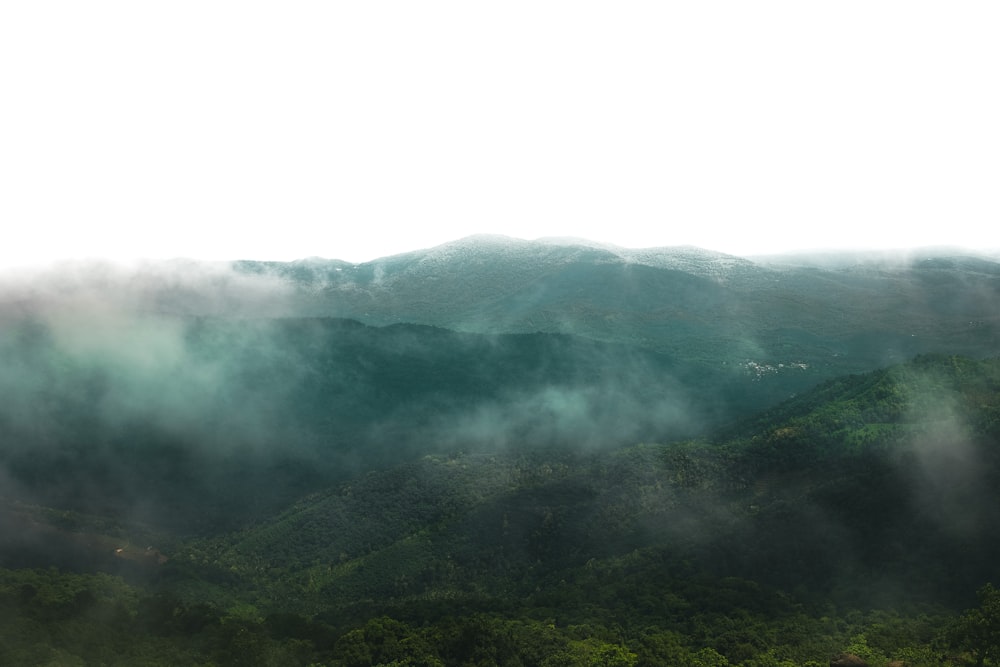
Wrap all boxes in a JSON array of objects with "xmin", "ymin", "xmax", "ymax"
[{"xmin": 170, "ymin": 357, "xmax": 1000, "ymax": 615}]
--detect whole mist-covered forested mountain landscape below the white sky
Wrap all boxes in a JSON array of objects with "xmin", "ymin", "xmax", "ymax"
[{"xmin": 0, "ymin": 236, "xmax": 1000, "ymax": 667}]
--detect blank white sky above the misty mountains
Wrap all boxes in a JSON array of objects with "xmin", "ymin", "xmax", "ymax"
[{"xmin": 0, "ymin": 0, "xmax": 1000, "ymax": 265}]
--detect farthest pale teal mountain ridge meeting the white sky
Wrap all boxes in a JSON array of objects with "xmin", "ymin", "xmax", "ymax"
[{"xmin": 229, "ymin": 237, "xmax": 1000, "ymax": 384}]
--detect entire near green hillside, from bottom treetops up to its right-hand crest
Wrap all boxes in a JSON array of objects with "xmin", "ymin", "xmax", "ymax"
[{"xmin": 0, "ymin": 355, "xmax": 1000, "ymax": 667}]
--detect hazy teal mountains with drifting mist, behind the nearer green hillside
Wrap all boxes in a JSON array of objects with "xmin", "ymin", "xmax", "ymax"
[{"xmin": 0, "ymin": 238, "xmax": 1000, "ymax": 532}]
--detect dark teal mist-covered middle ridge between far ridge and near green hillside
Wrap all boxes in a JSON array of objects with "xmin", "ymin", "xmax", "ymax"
[{"xmin": 0, "ymin": 313, "xmax": 764, "ymax": 532}]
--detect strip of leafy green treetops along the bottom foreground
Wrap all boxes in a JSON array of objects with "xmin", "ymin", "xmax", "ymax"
[{"xmin": 0, "ymin": 562, "xmax": 1000, "ymax": 667}]
